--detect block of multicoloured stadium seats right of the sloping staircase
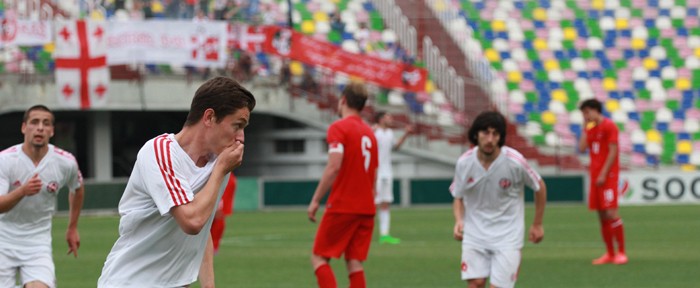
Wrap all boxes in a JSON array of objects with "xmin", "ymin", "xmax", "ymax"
[{"xmin": 428, "ymin": 0, "xmax": 700, "ymax": 170}]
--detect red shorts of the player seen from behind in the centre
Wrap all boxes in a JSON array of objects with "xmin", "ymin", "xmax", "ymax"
[{"xmin": 314, "ymin": 213, "xmax": 374, "ymax": 261}]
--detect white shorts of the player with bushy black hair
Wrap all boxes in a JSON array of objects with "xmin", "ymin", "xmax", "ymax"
[{"xmin": 461, "ymin": 245, "xmax": 520, "ymax": 288}]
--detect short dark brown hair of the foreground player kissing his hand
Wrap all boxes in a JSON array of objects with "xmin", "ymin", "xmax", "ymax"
[{"xmin": 185, "ymin": 77, "xmax": 255, "ymax": 126}]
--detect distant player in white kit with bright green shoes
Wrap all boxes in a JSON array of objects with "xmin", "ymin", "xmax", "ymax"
[{"xmin": 374, "ymin": 111, "xmax": 413, "ymax": 244}]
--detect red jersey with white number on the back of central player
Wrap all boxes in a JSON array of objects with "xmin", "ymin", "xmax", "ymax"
[{"xmin": 326, "ymin": 116, "xmax": 379, "ymax": 215}]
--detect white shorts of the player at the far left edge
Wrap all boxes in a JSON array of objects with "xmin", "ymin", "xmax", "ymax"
[{"xmin": 0, "ymin": 249, "xmax": 56, "ymax": 288}]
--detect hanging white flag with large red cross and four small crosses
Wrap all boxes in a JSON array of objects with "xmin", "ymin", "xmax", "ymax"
[{"xmin": 54, "ymin": 20, "xmax": 109, "ymax": 109}]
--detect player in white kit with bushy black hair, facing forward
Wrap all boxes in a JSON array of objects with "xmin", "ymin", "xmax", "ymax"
[{"xmin": 450, "ymin": 112, "xmax": 547, "ymax": 288}]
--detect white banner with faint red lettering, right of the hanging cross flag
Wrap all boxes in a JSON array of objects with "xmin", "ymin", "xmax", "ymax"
[{"xmin": 107, "ymin": 21, "xmax": 228, "ymax": 67}]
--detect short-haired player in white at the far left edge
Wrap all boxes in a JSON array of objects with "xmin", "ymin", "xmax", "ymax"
[{"xmin": 0, "ymin": 105, "xmax": 85, "ymax": 288}]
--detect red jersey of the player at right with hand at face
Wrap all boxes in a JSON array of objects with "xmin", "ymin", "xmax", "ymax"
[{"xmin": 586, "ymin": 118, "xmax": 620, "ymax": 181}]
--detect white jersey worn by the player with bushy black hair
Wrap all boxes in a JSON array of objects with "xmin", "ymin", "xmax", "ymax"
[{"xmin": 450, "ymin": 146, "xmax": 542, "ymax": 249}]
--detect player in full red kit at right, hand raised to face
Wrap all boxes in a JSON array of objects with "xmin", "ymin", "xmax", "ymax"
[{"xmin": 579, "ymin": 99, "xmax": 627, "ymax": 265}]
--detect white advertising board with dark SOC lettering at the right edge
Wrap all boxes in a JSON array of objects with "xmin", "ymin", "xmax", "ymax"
[{"xmin": 619, "ymin": 171, "xmax": 700, "ymax": 205}]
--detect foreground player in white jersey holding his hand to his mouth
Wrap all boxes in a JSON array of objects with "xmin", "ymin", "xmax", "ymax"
[{"xmin": 97, "ymin": 77, "xmax": 255, "ymax": 287}]
